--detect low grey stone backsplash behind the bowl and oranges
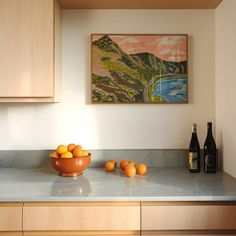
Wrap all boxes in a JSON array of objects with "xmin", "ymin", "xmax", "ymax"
[{"xmin": 0, "ymin": 149, "xmax": 188, "ymax": 168}]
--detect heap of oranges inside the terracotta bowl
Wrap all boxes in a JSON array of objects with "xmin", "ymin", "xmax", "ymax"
[{"xmin": 49, "ymin": 143, "xmax": 89, "ymax": 158}]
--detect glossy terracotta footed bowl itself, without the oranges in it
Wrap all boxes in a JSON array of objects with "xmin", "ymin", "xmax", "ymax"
[{"xmin": 51, "ymin": 154, "xmax": 91, "ymax": 177}]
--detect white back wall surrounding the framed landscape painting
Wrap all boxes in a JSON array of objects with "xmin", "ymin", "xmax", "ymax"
[{"xmin": 0, "ymin": 10, "xmax": 215, "ymax": 149}]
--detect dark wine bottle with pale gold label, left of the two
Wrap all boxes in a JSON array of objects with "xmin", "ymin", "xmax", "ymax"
[{"xmin": 188, "ymin": 124, "xmax": 201, "ymax": 173}]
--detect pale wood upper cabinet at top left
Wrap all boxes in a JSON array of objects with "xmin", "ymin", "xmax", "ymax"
[{"xmin": 0, "ymin": 0, "xmax": 61, "ymax": 102}]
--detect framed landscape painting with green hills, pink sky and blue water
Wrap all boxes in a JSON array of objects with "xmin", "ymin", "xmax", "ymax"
[{"xmin": 91, "ymin": 34, "xmax": 188, "ymax": 104}]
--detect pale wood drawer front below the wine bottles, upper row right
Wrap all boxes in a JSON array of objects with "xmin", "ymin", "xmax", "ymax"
[{"xmin": 142, "ymin": 205, "xmax": 236, "ymax": 230}]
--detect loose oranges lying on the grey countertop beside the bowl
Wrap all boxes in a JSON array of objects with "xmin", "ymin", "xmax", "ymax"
[{"xmin": 105, "ymin": 160, "xmax": 147, "ymax": 177}]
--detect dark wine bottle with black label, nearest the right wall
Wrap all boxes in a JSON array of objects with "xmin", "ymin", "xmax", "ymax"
[{"xmin": 204, "ymin": 122, "xmax": 217, "ymax": 173}]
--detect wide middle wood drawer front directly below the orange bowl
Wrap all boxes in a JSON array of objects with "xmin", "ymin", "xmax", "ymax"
[{"xmin": 23, "ymin": 204, "xmax": 140, "ymax": 231}]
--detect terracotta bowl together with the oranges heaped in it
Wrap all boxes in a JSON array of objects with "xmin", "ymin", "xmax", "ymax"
[{"xmin": 49, "ymin": 143, "xmax": 91, "ymax": 177}]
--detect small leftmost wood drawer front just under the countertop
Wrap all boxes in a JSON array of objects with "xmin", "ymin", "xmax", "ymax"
[{"xmin": 0, "ymin": 204, "xmax": 22, "ymax": 231}]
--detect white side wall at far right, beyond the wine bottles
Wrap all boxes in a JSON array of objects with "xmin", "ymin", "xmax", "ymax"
[{"xmin": 216, "ymin": 0, "xmax": 236, "ymax": 177}]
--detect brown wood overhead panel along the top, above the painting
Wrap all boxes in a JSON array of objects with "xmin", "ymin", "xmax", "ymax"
[{"xmin": 59, "ymin": 0, "xmax": 222, "ymax": 9}]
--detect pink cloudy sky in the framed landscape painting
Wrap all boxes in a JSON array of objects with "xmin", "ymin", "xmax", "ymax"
[{"xmin": 92, "ymin": 35, "xmax": 187, "ymax": 62}]
